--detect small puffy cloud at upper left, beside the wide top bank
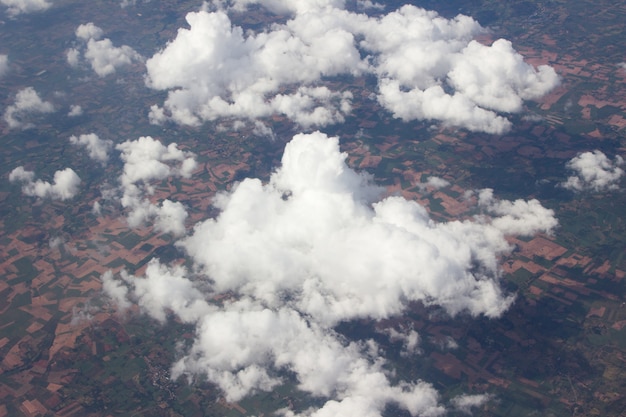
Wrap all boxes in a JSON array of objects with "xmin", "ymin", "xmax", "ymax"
[{"xmin": 67, "ymin": 22, "xmax": 143, "ymax": 77}]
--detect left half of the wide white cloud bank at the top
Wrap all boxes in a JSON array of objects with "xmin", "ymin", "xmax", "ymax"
[{"xmin": 146, "ymin": 12, "xmax": 360, "ymax": 126}]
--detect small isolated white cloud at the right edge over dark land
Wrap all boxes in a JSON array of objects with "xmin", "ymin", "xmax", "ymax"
[{"xmin": 561, "ymin": 150, "xmax": 624, "ymax": 192}]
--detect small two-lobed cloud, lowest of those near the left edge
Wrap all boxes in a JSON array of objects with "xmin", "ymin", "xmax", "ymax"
[{"xmin": 9, "ymin": 166, "xmax": 80, "ymax": 200}]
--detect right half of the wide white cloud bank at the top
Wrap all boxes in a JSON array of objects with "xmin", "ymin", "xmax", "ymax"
[{"xmin": 363, "ymin": 6, "xmax": 559, "ymax": 133}]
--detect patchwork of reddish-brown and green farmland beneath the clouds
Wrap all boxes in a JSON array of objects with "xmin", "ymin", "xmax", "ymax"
[{"xmin": 0, "ymin": 0, "xmax": 626, "ymax": 417}]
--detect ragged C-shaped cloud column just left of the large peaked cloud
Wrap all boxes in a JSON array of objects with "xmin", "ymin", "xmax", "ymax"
[{"xmin": 115, "ymin": 136, "xmax": 197, "ymax": 235}]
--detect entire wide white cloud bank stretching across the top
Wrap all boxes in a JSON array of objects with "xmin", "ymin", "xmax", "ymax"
[{"xmin": 146, "ymin": 0, "xmax": 558, "ymax": 133}]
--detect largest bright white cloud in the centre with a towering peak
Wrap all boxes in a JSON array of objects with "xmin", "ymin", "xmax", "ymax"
[{"xmin": 182, "ymin": 133, "xmax": 553, "ymax": 323}]
